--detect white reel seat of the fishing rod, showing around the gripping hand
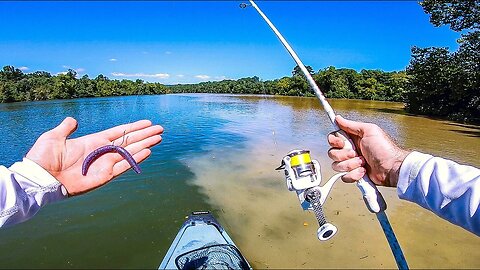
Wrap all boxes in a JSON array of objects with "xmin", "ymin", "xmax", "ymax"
[{"xmin": 335, "ymin": 130, "xmax": 387, "ymax": 213}]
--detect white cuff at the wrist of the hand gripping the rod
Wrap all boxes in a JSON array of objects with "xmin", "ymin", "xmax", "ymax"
[{"xmin": 397, "ymin": 151, "xmax": 433, "ymax": 199}]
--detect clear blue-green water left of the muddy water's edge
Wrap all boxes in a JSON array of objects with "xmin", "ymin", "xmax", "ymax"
[{"xmin": 0, "ymin": 95, "xmax": 246, "ymax": 268}]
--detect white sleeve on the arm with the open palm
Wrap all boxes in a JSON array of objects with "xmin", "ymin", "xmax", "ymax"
[{"xmin": 0, "ymin": 159, "xmax": 67, "ymax": 227}]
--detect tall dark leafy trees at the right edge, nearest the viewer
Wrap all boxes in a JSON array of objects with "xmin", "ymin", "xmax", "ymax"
[{"xmin": 405, "ymin": 0, "xmax": 480, "ymax": 123}]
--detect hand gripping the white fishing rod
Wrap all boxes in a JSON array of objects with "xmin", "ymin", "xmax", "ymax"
[{"xmin": 328, "ymin": 116, "xmax": 410, "ymax": 187}]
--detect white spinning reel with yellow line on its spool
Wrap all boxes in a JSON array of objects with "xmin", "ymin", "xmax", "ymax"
[{"xmin": 276, "ymin": 150, "xmax": 345, "ymax": 241}]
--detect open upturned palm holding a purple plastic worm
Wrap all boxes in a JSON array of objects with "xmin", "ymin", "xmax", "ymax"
[{"xmin": 26, "ymin": 117, "xmax": 163, "ymax": 195}]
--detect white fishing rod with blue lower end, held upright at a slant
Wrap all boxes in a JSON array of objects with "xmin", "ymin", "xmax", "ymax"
[{"xmin": 240, "ymin": 0, "xmax": 408, "ymax": 269}]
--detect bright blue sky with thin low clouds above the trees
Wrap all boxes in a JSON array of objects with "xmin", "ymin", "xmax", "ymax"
[{"xmin": 0, "ymin": 1, "xmax": 459, "ymax": 84}]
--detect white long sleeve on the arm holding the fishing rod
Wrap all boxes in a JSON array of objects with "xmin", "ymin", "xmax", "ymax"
[{"xmin": 397, "ymin": 152, "xmax": 480, "ymax": 236}]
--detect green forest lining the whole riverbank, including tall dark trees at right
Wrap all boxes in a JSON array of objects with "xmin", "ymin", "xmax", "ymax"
[{"xmin": 0, "ymin": 0, "xmax": 480, "ymax": 124}]
